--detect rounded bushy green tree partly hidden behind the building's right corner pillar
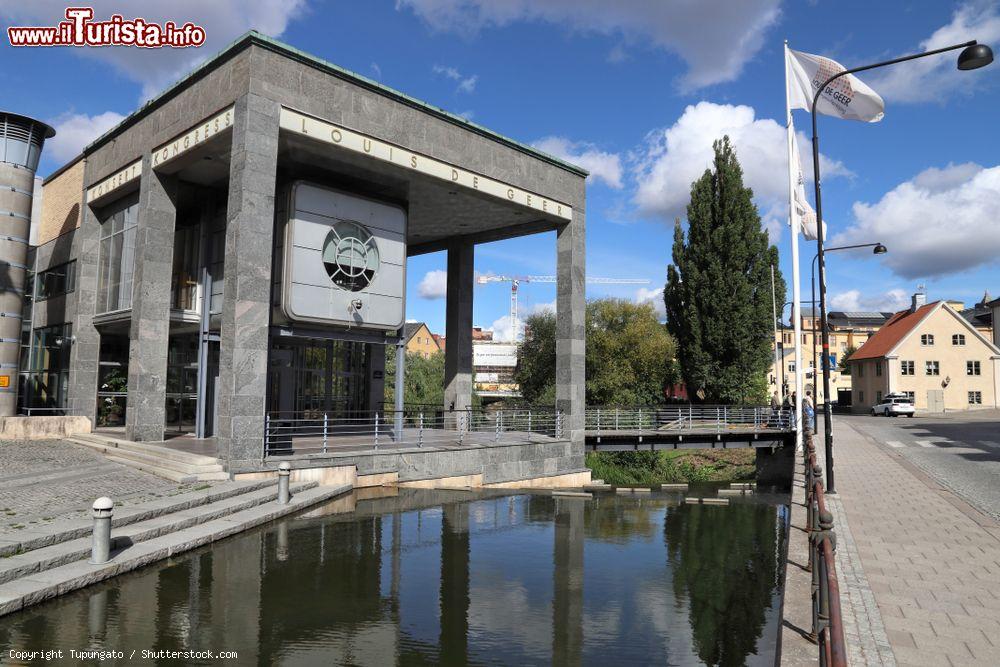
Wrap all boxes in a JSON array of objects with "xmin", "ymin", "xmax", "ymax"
[{"xmin": 515, "ymin": 299, "xmax": 676, "ymax": 405}]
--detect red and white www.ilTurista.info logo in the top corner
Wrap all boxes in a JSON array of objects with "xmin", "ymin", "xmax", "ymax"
[{"xmin": 7, "ymin": 7, "xmax": 205, "ymax": 49}]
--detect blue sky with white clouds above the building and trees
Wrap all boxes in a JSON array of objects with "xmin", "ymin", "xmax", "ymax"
[{"xmin": 0, "ymin": 0, "xmax": 1000, "ymax": 340}]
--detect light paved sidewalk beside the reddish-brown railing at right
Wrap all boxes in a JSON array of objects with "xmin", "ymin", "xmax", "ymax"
[{"xmin": 818, "ymin": 418, "xmax": 1000, "ymax": 667}]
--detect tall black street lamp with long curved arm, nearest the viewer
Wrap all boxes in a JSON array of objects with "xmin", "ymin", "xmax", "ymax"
[{"xmin": 811, "ymin": 40, "xmax": 993, "ymax": 494}]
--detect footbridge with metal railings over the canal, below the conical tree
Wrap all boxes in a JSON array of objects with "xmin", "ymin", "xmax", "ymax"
[{"xmin": 585, "ymin": 405, "xmax": 795, "ymax": 452}]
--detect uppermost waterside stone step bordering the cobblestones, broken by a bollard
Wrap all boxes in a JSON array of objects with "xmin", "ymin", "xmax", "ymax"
[{"xmin": 0, "ymin": 479, "xmax": 277, "ymax": 558}]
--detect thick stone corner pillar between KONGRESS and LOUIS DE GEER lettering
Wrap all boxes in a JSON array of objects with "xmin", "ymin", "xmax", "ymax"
[{"xmin": 216, "ymin": 93, "xmax": 280, "ymax": 471}]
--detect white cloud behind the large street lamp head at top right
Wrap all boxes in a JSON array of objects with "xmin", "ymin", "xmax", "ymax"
[{"xmin": 871, "ymin": 2, "xmax": 1000, "ymax": 102}]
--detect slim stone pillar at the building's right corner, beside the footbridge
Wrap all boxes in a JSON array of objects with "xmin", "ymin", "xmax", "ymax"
[{"xmin": 556, "ymin": 214, "xmax": 587, "ymax": 445}]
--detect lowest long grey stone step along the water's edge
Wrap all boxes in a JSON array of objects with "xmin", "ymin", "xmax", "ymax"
[{"xmin": 0, "ymin": 485, "xmax": 351, "ymax": 616}]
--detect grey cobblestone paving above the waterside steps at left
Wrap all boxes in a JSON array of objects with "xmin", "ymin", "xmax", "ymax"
[{"xmin": 0, "ymin": 440, "xmax": 205, "ymax": 534}]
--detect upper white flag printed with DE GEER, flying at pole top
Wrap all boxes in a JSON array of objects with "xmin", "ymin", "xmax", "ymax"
[{"xmin": 788, "ymin": 49, "xmax": 885, "ymax": 123}]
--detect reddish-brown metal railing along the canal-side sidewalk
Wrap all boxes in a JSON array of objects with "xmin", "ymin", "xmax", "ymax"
[{"xmin": 804, "ymin": 433, "xmax": 847, "ymax": 667}]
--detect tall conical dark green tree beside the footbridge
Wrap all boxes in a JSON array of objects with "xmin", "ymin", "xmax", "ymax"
[{"xmin": 663, "ymin": 136, "xmax": 785, "ymax": 403}]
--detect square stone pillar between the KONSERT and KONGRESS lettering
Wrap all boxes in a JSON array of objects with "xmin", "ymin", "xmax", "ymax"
[{"xmin": 125, "ymin": 159, "xmax": 177, "ymax": 442}]
